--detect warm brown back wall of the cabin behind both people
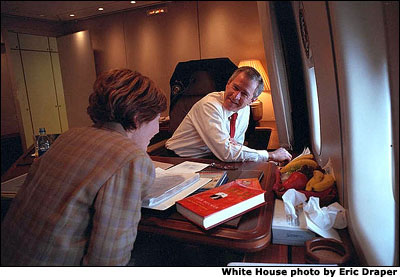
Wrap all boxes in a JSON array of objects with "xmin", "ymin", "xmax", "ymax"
[{"xmin": 65, "ymin": 1, "xmax": 268, "ymax": 116}]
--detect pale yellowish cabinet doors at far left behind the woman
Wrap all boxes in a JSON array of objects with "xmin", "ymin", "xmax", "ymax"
[{"xmin": 8, "ymin": 32, "xmax": 68, "ymax": 148}]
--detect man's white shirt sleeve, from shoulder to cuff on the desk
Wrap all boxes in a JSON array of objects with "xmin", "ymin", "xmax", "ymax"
[{"xmin": 192, "ymin": 99, "xmax": 268, "ymax": 162}]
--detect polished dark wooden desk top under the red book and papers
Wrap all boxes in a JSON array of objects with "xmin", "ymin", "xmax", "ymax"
[{"xmin": 138, "ymin": 157, "xmax": 275, "ymax": 252}]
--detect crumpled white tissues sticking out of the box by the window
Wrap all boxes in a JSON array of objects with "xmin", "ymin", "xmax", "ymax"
[{"xmin": 282, "ymin": 189, "xmax": 347, "ymax": 241}]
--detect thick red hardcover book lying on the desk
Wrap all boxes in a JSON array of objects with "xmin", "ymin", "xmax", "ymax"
[{"xmin": 176, "ymin": 179, "xmax": 265, "ymax": 230}]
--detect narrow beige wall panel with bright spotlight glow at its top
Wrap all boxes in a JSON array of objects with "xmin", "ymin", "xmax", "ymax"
[{"xmin": 57, "ymin": 31, "xmax": 96, "ymax": 128}]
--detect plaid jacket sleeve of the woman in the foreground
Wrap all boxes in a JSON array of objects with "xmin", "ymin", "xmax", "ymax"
[{"xmin": 82, "ymin": 154, "xmax": 154, "ymax": 266}]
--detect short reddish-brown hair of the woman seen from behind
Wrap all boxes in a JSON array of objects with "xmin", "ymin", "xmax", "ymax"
[{"xmin": 87, "ymin": 69, "xmax": 167, "ymax": 131}]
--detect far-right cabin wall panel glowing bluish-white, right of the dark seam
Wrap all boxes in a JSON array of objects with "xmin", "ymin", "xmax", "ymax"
[{"xmin": 329, "ymin": 2, "xmax": 398, "ymax": 265}]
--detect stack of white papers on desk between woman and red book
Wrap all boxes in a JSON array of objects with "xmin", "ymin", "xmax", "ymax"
[{"xmin": 142, "ymin": 161, "xmax": 211, "ymax": 210}]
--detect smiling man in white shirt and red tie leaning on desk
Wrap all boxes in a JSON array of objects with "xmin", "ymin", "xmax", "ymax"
[{"xmin": 165, "ymin": 66, "xmax": 292, "ymax": 162}]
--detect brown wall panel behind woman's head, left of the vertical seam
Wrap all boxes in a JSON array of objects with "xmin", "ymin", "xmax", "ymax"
[{"xmin": 124, "ymin": 1, "xmax": 200, "ymax": 113}]
